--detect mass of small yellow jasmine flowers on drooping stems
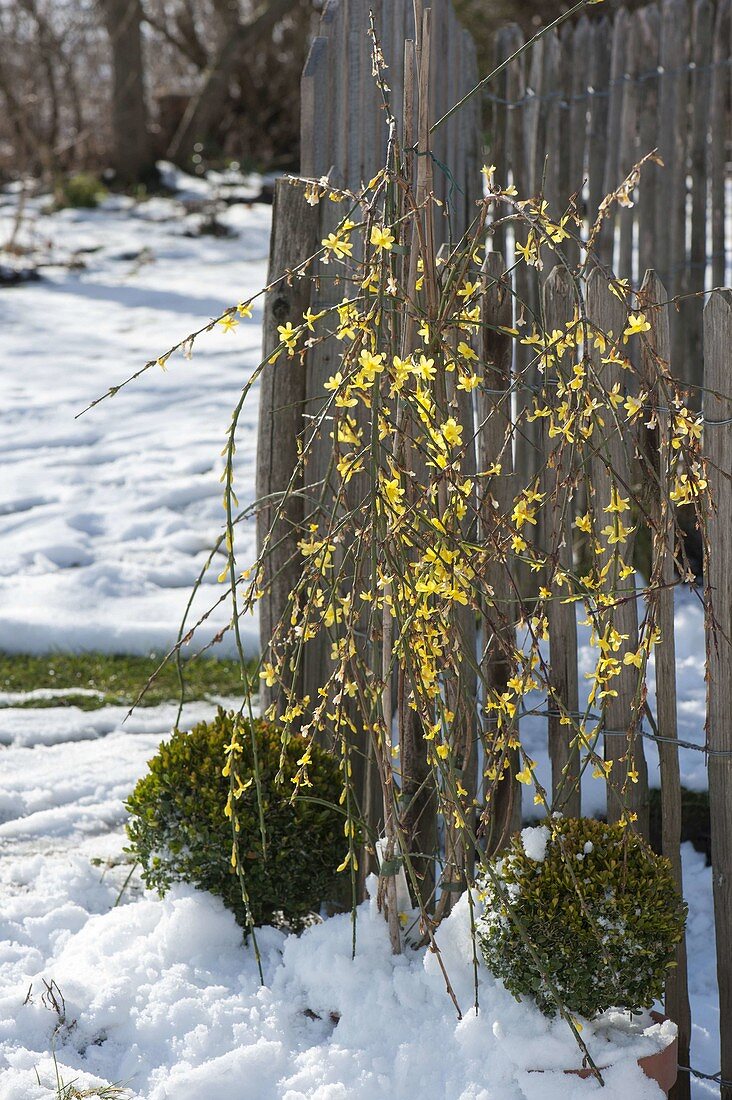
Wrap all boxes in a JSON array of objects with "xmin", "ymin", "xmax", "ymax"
[{"xmin": 232, "ymin": 157, "xmax": 707, "ymax": 849}]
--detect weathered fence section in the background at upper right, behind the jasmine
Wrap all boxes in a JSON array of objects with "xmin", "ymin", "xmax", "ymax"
[{"xmin": 484, "ymin": 0, "xmax": 732, "ymax": 407}]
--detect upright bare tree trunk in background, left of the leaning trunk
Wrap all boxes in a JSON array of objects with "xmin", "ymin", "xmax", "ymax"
[{"xmin": 99, "ymin": 0, "xmax": 155, "ymax": 184}]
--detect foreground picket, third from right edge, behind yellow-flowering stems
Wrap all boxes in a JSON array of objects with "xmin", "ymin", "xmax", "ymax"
[{"xmin": 587, "ymin": 268, "xmax": 648, "ymax": 839}]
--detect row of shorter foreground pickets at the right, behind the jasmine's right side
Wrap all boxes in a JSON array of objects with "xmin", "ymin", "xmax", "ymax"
[{"xmin": 468, "ymin": 259, "xmax": 732, "ymax": 1100}]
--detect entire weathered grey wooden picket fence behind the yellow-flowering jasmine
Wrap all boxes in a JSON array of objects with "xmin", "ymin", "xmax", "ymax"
[{"xmin": 256, "ymin": 0, "xmax": 732, "ymax": 1100}]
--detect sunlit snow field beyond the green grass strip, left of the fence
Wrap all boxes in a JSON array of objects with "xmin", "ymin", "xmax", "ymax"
[{"xmin": 0, "ymin": 173, "xmax": 263, "ymax": 653}]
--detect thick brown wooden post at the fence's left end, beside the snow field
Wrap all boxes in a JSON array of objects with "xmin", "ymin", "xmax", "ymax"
[{"xmin": 256, "ymin": 179, "xmax": 318, "ymax": 711}]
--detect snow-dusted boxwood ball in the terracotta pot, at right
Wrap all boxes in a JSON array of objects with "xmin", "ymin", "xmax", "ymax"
[{"xmin": 478, "ymin": 817, "xmax": 686, "ymax": 1019}]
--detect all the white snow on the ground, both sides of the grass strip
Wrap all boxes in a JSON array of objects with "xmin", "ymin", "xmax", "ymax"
[{"xmin": 0, "ymin": 176, "xmax": 718, "ymax": 1100}]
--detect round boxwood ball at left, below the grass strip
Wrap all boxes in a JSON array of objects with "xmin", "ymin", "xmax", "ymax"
[{"xmin": 127, "ymin": 710, "xmax": 345, "ymax": 928}]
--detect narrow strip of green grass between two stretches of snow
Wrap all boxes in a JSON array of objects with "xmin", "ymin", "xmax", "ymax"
[{"xmin": 0, "ymin": 651, "xmax": 250, "ymax": 711}]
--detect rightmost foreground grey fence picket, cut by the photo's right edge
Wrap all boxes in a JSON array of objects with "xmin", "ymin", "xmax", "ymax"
[{"xmin": 703, "ymin": 289, "xmax": 732, "ymax": 1100}]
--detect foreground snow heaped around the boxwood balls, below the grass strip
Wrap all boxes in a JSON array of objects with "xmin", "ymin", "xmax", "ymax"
[{"xmin": 0, "ymin": 708, "xmax": 709, "ymax": 1100}]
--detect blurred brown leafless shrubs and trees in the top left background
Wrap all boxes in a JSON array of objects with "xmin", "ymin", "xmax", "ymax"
[{"xmin": 0, "ymin": 0, "xmax": 318, "ymax": 184}]
